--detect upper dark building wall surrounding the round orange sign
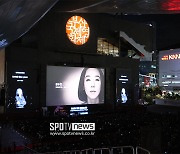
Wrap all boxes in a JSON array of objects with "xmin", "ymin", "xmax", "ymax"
[{"xmin": 38, "ymin": 10, "xmax": 155, "ymax": 53}]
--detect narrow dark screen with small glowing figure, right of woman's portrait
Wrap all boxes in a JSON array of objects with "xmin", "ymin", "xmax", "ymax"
[{"xmin": 116, "ymin": 69, "xmax": 131, "ymax": 104}]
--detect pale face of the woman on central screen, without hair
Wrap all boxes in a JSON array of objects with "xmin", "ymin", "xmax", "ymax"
[{"xmin": 84, "ymin": 68, "xmax": 101, "ymax": 99}]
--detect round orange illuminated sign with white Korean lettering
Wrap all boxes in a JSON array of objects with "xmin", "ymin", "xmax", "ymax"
[{"xmin": 66, "ymin": 16, "xmax": 90, "ymax": 45}]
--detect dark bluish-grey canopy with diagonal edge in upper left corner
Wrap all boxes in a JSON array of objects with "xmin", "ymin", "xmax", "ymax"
[{"xmin": 0, "ymin": 0, "xmax": 58, "ymax": 48}]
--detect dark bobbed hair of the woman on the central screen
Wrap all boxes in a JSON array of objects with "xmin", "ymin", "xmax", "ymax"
[{"xmin": 78, "ymin": 68, "xmax": 104, "ymax": 102}]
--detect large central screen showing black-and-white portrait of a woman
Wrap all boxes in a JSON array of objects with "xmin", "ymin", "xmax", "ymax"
[{"xmin": 46, "ymin": 66, "xmax": 104, "ymax": 106}]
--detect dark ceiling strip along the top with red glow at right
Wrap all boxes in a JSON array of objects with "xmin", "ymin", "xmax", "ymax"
[{"xmin": 58, "ymin": 0, "xmax": 180, "ymax": 15}]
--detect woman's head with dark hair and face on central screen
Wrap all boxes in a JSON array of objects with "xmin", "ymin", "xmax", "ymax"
[{"xmin": 78, "ymin": 68, "xmax": 104, "ymax": 104}]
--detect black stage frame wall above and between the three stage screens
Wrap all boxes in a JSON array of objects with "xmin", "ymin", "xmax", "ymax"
[{"xmin": 6, "ymin": 47, "xmax": 139, "ymax": 106}]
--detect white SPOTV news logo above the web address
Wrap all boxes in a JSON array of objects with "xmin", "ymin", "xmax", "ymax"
[{"xmin": 50, "ymin": 123, "xmax": 95, "ymax": 131}]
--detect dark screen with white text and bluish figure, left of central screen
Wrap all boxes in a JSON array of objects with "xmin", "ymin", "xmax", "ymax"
[{"xmin": 6, "ymin": 67, "xmax": 38, "ymax": 111}]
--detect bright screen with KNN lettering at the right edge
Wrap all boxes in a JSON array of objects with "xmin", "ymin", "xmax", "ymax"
[{"xmin": 159, "ymin": 49, "xmax": 180, "ymax": 87}]
